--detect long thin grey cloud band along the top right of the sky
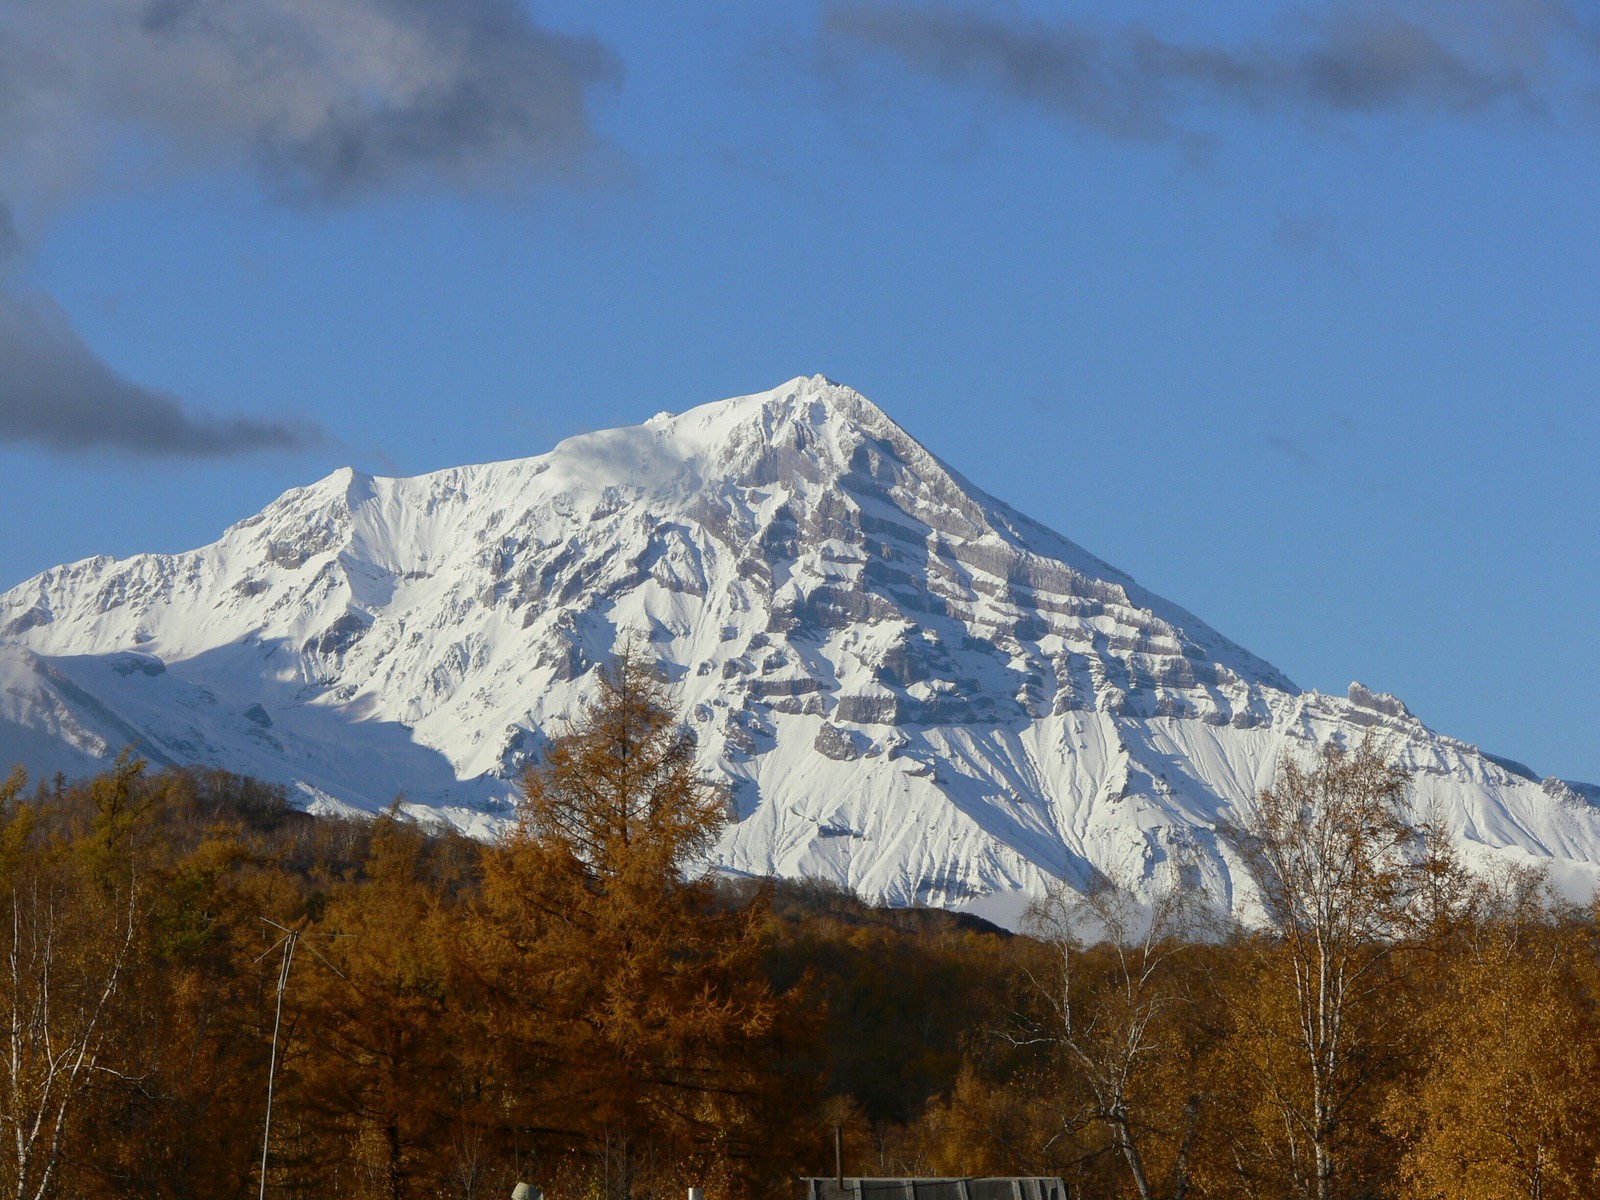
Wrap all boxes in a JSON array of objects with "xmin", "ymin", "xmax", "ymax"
[{"xmin": 824, "ymin": 0, "xmax": 1597, "ymax": 141}]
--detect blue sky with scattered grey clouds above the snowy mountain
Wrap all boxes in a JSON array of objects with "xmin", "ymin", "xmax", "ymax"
[{"xmin": 0, "ymin": 0, "xmax": 1600, "ymax": 781}]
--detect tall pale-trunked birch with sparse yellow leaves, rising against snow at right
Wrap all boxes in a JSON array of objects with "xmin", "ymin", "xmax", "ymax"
[{"xmin": 1232, "ymin": 741, "xmax": 1448, "ymax": 1200}]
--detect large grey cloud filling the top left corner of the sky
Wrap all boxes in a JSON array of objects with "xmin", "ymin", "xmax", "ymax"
[{"xmin": 0, "ymin": 0, "xmax": 619, "ymax": 202}]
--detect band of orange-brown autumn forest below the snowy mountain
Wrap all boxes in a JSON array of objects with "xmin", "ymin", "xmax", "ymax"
[{"xmin": 0, "ymin": 656, "xmax": 1600, "ymax": 1200}]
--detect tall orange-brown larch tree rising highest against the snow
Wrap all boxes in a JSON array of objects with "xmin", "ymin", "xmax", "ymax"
[{"xmin": 475, "ymin": 646, "xmax": 795, "ymax": 1197}]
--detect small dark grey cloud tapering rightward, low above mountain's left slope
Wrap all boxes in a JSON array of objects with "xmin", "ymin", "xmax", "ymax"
[{"xmin": 0, "ymin": 294, "xmax": 322, "ymax": 459}]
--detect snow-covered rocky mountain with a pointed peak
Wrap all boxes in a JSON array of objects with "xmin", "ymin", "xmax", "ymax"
[{"xmin": 0, "ymin": 376, "xmax": 1600, "ymax": 920}]
